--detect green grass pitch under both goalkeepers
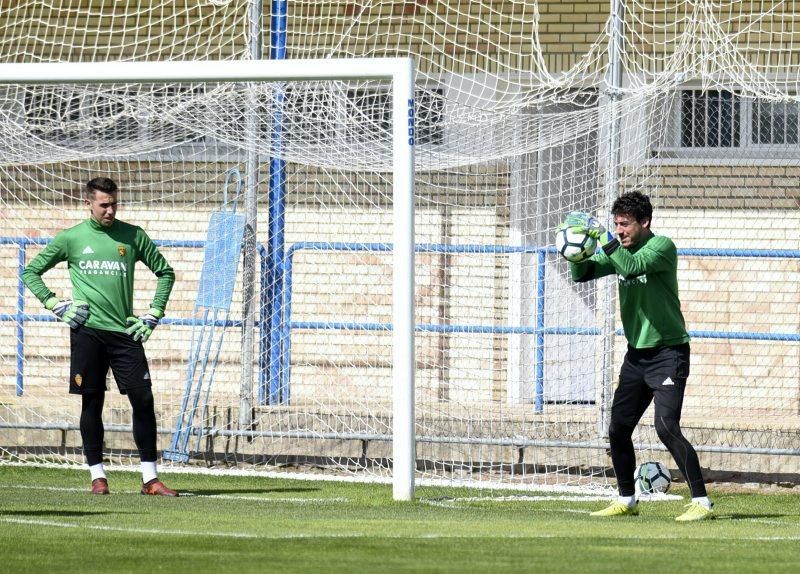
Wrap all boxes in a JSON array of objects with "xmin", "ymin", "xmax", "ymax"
[{"xmin": 0, "ymin": 466, "xmax": 800, "ymax": 574}]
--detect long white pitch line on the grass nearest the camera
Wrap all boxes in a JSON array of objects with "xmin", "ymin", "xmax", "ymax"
[{"xmin": 0, "ymin": 517, "xmax": 800, "ymax": 542}]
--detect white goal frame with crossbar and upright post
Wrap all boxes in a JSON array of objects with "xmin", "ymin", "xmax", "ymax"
[{"xmin": 0, "ymin": 58, "xmax": 416, "ymax": 500}]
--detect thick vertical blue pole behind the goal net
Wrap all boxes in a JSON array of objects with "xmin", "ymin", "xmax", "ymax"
[{"xmin": 267, "ymin": 0, "xmax": 288, "ymax": 405}]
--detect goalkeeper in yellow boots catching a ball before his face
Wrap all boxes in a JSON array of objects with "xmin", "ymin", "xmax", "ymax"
[{"xmin": 563, "ymin": 191, "xmax": 714, "ymax": 522}]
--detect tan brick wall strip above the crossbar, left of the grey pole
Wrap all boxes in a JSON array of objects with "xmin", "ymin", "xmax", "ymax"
[{"xmin": 0, "ymin": 0, "xmax": 248, "ymax": 63}]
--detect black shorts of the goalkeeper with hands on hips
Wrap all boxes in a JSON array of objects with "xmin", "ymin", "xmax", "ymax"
[{"xmin": 69, "ymin": 326, "xmax": 151, "ymax": 395}]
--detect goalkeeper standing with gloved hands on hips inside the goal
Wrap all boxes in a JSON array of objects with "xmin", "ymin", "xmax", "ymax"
[{"xmin": 22, "ymin": 177, "xmax": 178, "ymax": 496}]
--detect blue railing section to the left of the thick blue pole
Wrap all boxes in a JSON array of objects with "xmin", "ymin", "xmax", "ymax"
[{"xmin": 0, "ymin": 237, "xmax": 266, "ymax": 396}]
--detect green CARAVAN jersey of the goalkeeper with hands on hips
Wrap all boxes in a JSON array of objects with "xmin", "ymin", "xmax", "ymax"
[{"xmin": 22, "ymin": 218, "xmax": 175, "ymax": 332}]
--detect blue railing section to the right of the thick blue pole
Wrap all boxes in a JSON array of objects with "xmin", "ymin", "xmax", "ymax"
[{"xmin": 274, "ymin": 242, "xmax": 800, "ymax": 412}]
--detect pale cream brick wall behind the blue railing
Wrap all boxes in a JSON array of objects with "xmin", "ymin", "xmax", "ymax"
[{"xmin": 0, "ymin": 187, "xmax": 800, "ymax": 430}]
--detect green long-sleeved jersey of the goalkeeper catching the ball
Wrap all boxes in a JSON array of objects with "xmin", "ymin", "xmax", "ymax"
[{"xmin": 570, "ymin": 235, "xmax": 689, "ymax": 349}]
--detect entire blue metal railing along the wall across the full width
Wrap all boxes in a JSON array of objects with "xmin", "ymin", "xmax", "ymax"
[{"xmin": 0, "ymin": 237, "xmax": 800, "ymax": 411}]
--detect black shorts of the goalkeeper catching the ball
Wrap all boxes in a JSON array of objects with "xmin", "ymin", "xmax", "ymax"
[{"xmin": 611, "ymin": 343, "xmax": 690, "ymax": 427}]
